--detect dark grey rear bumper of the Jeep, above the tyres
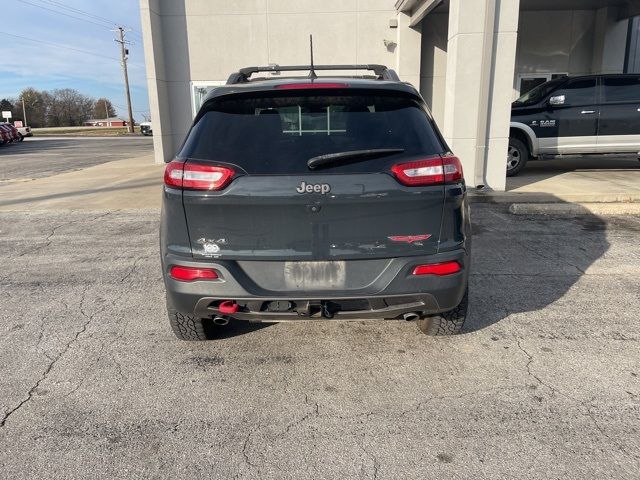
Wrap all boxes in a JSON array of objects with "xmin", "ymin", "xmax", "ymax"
[{"xmin": 163, "ymin": 249, "xmax": 469, "ymax": 322}]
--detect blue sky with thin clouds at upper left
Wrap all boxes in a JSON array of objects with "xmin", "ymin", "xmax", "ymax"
[{"xmin": 0, "ymin": 0, "xmax": 149, "ymax": 121}]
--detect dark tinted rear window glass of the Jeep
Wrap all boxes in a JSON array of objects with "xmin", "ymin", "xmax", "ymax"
[{"xmin": 178, "ymin": 93, "xmax": 444, "ymax": 174}]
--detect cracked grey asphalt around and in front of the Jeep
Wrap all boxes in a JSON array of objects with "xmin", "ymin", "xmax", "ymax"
[{"xmin": 0, "ymin": 205, "xmax": 640, "ymax": 479}]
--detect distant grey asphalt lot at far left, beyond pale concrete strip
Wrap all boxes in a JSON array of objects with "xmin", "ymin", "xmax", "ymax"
[{"xmin": 0, "ymin": 136, "xmax": 153, "ymax": 183}]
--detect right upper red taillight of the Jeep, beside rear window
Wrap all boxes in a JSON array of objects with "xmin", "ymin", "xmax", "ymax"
[{"xmin": 391, "ymin": 156, "xmax": 462, "ymax": 187}]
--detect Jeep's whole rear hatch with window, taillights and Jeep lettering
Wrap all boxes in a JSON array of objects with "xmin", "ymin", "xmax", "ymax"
[{"xmin": 165, "ymin": 88, "xmax": 462, "ymax": 266}]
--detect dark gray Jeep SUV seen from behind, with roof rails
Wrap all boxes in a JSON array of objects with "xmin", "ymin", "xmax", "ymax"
[{"xmin": 160, "ymin": 65, "xmax": 471, "ymax": 340}]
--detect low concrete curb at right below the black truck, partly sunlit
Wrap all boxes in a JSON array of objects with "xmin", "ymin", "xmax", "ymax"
[{"xmin": 509, "ymin": 202, "xmax": 640, "ymax": 216}]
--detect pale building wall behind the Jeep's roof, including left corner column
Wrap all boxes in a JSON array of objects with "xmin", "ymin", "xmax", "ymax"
[{"xmin": 141, "ymin": 0, "xmax": 421, "ymax": 162}]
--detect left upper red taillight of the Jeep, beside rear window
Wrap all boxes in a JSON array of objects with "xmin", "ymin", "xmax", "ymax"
[{"xmin": 164, "ymin": 160, "xmax": 235, "ymax": 190}]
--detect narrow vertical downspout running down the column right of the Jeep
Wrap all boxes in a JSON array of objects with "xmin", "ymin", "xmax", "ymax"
[{"xmin": 473, "ymin": 0, "xmax": 498, "ymax": 188}]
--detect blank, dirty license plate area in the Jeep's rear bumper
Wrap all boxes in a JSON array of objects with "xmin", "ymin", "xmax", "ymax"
[{"xmin": 284, "ymin": 261, "xmax": 347, "ymax": 290}]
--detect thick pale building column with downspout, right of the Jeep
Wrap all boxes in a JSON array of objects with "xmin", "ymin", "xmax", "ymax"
[{"xmin": 443, "ymin": 0, "xmax": 520, "ymax": 190}]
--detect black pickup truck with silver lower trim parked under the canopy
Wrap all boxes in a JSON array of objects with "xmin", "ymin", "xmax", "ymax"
[{"xmin": 507, "ymin": 74, "xmax": 640, "ymax": 176}]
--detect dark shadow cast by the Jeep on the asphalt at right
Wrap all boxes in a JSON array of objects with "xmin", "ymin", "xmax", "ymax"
[{"xmin": 465, "ymin": 195, "xmax": 610, "ymax": 332}]
